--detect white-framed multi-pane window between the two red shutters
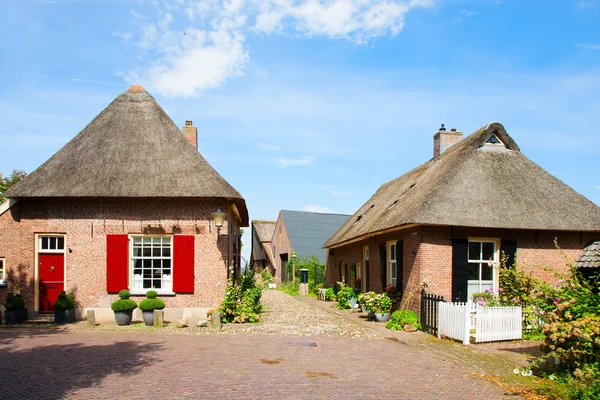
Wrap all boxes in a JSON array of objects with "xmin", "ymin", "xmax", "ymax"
[{"xmin": 131, "ymin": 236, "xmax": 173, "ymax": 292}]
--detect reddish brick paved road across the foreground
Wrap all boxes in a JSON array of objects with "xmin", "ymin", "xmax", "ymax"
[{"xmin": 0, "ymin": 328, "xmax": 512, "ymax": 400}]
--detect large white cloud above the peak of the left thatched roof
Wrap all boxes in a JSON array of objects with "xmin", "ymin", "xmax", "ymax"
[{"xmin": 126, "ymin": 0, "xmax": 433, "ymax": 97}]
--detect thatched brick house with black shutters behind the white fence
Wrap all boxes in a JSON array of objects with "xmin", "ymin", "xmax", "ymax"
[{"xmin": 324, "ymin": 123, "xmax": 600, "ymax": 309}]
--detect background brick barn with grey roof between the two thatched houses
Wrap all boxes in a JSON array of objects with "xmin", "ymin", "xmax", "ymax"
[{"xmin": 271, "ymin": 210, "xmax": 350, "ymax": 283}]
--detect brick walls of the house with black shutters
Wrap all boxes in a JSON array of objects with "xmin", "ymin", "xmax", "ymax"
[{"xmin": 326, "ymin": 226, "xmax": 600, "ymax": 311}]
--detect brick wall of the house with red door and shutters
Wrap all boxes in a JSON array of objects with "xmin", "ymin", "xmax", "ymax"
[{"xmin": 0, "ymin": 199, "xmax": 237, "ymax": 308}]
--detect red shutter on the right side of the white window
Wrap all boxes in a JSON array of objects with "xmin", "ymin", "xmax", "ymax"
[{"xmin": 173, "ymin": 235, "xmax": 194, "ymax": 293}]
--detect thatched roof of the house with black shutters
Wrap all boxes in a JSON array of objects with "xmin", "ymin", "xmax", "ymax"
[{"xmin": 324, "ymin": 123, "xmax": 600, "ymax": 247}]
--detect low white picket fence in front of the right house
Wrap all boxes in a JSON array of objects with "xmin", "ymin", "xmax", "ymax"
[{"xmin": 438, "ymin": 302, "xmax": 523, "ymax": 344}]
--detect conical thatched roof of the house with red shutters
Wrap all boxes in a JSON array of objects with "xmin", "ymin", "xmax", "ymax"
[{"xmin": 7, "ymin": 85, "xmax": 248, "ymax": 226}]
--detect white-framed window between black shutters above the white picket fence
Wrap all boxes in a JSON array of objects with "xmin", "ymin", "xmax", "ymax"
[{"xmin": 467, "ymin": 239, "xmax": 498, "ymax": 300}]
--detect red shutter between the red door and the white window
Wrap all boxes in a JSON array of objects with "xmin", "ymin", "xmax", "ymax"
[{"xmin": 106, "ymin": 235, "xmax": 129, "ymax": 293}]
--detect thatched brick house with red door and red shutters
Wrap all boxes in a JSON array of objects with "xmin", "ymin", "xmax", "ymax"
[{"xmin": 0, "ymin": 85, "xmax": 248, "ymax": 320}]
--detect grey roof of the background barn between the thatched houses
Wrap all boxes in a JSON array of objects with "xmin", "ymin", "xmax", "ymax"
[{"xmin": 281, "ymin": 210, "xmax": 350, "ymax": 264}]
